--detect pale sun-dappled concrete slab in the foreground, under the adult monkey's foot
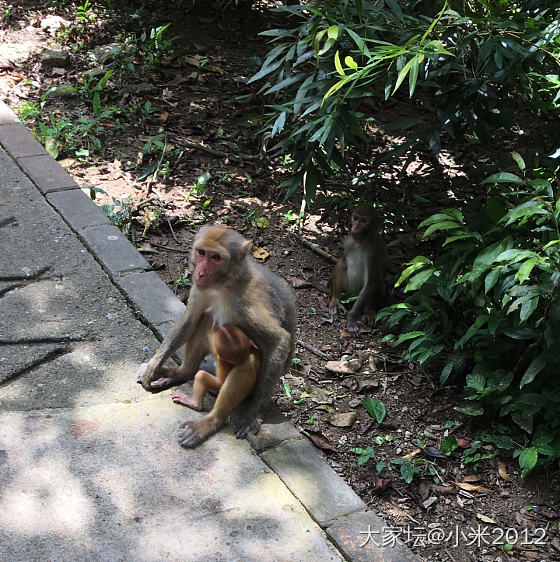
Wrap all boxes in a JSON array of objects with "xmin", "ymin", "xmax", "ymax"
[{"xmin": 0, "ymin": 397, "xmax": 342, "ymax": 562}]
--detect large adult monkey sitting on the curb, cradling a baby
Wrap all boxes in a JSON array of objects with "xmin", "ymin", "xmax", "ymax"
[{"xmin": 138, "ymin": 225, "xmax": 296, "ymax": 447}]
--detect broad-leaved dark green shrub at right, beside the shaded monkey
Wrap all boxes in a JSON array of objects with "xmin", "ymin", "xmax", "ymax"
[{"xmin": 378, "ymin": 154, "xmax": 560, "ymax": 472}]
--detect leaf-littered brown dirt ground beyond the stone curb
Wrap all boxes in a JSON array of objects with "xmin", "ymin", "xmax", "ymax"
[{"xmin": 0, "ymin": 0, "xmax": 560, "ymax": 562}]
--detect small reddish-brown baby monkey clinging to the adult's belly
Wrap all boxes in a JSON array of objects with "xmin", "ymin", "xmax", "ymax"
[{"xmin": 171, "ymin": 324, "xmax": 261, "ymax": 414}]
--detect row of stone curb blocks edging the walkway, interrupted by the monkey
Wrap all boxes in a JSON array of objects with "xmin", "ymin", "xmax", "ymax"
[{"xmin": 0, "ymin": 101, "xmax": 419, "ymax": 562}]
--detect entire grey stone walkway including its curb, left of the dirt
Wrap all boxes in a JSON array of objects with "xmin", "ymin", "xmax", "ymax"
[{"xmin": 0, "ymin": 102, "xmax": 416, "ymax": 562}]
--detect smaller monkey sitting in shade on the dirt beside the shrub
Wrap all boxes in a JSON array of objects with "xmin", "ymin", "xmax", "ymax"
[{"xmin": 329, "ymin": 205, "xmax": 389, "ymax": 337}]
